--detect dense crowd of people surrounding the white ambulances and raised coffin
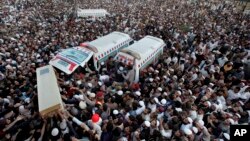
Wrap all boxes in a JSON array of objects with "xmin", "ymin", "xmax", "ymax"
[{"xmin": 0, "ymin": 0, "xmax": 250, "ymax": 141}]
